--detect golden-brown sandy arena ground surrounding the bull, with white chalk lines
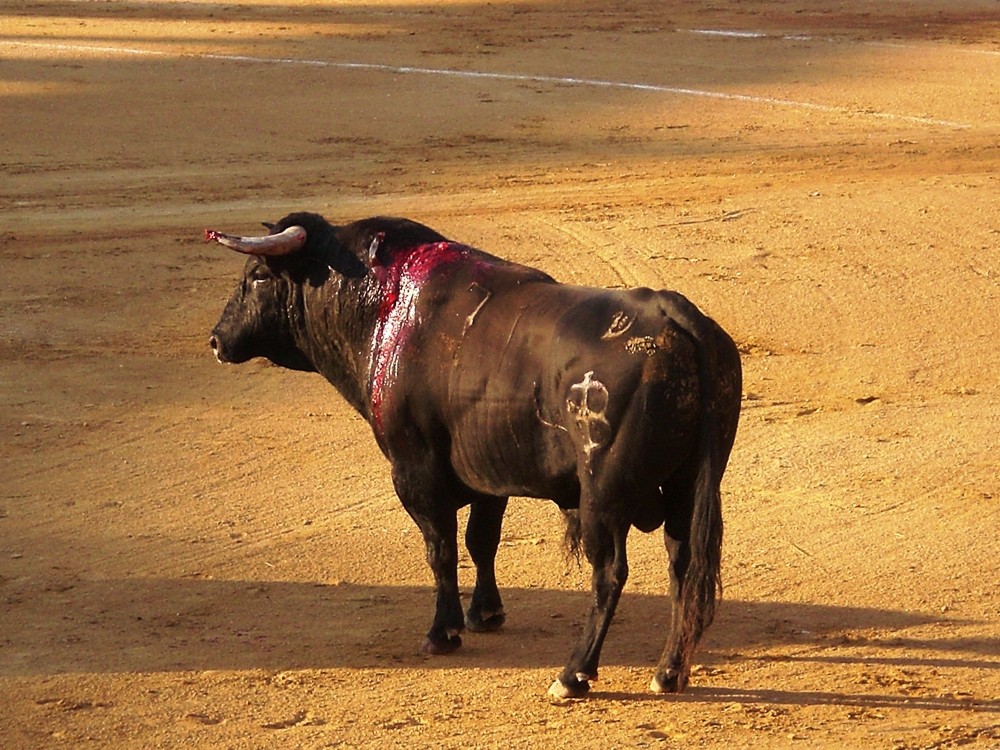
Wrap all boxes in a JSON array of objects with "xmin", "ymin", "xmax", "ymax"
[{"xmin": 0, "ymin": 0, "xmax": 1000, "ymax": 750}]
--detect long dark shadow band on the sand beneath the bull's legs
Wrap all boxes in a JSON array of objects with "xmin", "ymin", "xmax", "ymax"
[{"xmin": 0, "ymin": 578, "xmax": 1000, "ymax": 688}]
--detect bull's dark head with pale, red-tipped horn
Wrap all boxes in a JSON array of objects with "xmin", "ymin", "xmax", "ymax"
[{"xmin": 205, "ymin": 216, "xmax": 329, "ymax": 371}]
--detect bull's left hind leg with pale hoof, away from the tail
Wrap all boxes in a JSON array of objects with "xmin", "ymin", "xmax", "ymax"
[{"xmin": 549, "ymin": 509, "xmax": 629, "ymax": 698}]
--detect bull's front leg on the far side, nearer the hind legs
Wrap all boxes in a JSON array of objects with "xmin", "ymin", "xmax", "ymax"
[{"xmin": 465, "ymin": 497, "xmax": 507, "ymax": 633}]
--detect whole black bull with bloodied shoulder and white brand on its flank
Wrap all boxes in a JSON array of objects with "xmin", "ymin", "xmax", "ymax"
[{"xmin": 206, "ymin": 213, "xmax": 741, "ymax": 697}]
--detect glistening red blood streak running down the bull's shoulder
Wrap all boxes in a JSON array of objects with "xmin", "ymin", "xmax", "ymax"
[{"xmin": 369, "ymin": 242, "xmax": 469, "ymax": 433}]
